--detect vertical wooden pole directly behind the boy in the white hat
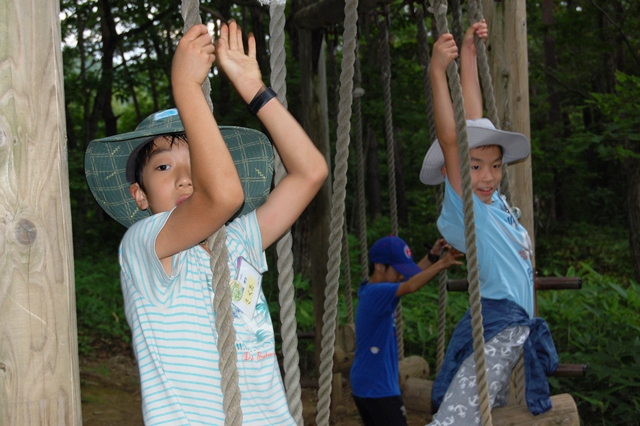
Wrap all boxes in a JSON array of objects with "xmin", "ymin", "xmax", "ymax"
[{"xmin": 482, "ymin": 0, "xmax": 535, "ymax": 260}]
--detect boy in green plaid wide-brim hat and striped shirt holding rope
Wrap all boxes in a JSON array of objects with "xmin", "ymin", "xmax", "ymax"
[{"xmin": 86, "ymin": 21, "xmax": 327, "ymax": 425}]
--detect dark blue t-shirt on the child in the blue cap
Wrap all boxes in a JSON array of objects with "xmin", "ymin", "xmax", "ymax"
[{"xmin": 350, "ymin": 281, "xmax": 400, "ymax": 398}]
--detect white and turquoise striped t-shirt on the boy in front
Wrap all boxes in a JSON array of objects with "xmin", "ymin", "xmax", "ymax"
[{"xmin": 120, "ymin": 212, "xmax": 295, "ymax": 426}]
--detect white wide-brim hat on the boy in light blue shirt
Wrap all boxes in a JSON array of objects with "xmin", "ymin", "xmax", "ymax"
[{"xmin": 420, "ymin": 118, "xmax": 531, "ymax": 185}]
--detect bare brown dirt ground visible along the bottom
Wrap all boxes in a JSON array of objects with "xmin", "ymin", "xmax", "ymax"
[{"xmin": 80, "ymin": 355, "xmax": 426, "ymax": 426}]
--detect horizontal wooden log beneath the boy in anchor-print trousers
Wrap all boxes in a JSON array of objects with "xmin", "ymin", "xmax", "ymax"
[{"xmin": 491, "ymin": 393, "xmax": 580, "ymax": 426}]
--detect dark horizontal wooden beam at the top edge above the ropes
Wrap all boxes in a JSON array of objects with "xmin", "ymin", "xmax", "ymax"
[{"xmin": 293, "ymin": 0, "xmax": 391, "ymax": 30}]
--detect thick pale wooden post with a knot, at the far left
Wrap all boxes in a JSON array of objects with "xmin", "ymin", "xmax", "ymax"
[{"xmin": 0, "ymin": 0, "xmax": 82, "ymax": 426}]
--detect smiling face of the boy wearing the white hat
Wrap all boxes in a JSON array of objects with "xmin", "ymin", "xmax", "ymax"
[{"xmin": 469, "ymin": 145, "xmax": 502, "ymax": 204}]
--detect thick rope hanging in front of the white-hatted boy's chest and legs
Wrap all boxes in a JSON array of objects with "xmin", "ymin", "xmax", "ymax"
[{"xmin": 431, "ymin": 0, "xmax": 492, "ymax": 426}]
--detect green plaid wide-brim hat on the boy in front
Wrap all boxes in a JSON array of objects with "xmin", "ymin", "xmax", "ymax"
[{"xmin": 84, "ymin": 108, "xmax": 273, "ymax": 228}]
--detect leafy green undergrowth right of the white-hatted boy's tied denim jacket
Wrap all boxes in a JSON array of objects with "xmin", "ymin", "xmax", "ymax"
[{"xmin": 538, "ymin": 264, "xmax": 640, "ymax": 425}]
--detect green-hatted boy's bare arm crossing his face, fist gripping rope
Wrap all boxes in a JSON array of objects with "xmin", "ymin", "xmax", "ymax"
[{"xmin": 156, "ymin": 25, "xmax": 244, "ymax": 259}]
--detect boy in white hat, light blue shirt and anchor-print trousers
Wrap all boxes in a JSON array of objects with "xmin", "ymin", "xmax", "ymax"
[{"xmin": 420, "ymin": 21, "xmax": 557, "ymax": 425}]
